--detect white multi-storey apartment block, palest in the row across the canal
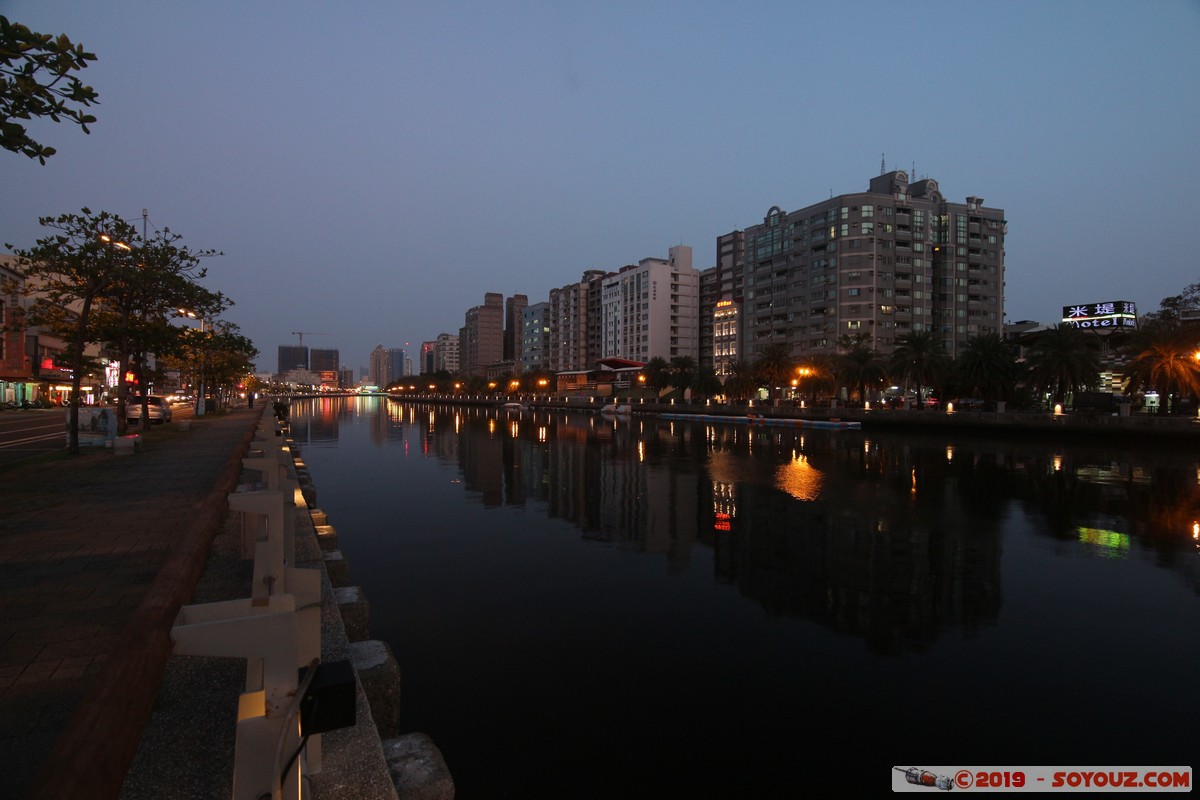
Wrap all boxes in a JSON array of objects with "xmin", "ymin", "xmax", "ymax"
[{"xmin": 600, "ymin": 245, "xmax": 700, "ymax": 362}]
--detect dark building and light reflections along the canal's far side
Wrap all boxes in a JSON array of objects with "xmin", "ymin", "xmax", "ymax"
[{"xmin": 293, "ymin": 398, "xmax": 1200, "ymax": 654}]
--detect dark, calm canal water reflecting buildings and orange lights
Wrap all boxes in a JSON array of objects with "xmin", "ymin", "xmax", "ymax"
[{"xmin": 285, "ymin": 398, "xmax": 1200, "ymax": 800}]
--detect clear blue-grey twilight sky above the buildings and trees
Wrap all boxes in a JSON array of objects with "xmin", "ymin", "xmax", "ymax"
[{"xmin": 0, "ymin": 0, "xmax": 1200, "ymax": 374}]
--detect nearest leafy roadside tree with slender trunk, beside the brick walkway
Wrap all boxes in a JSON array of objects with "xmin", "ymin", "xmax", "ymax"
[{"xmin": 6, "ymin": 209, "xmax": 137, "ymax": 453}]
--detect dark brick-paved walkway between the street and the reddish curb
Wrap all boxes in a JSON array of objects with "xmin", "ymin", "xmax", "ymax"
[{"xmin": 0, "ymin": 408, "xmax": 262, "ymax": 798}]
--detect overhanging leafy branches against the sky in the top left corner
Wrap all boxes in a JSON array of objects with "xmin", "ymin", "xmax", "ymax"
[{"xmin": 0, "ymin": 17, "xmax": 100, "ymax": 164}]
